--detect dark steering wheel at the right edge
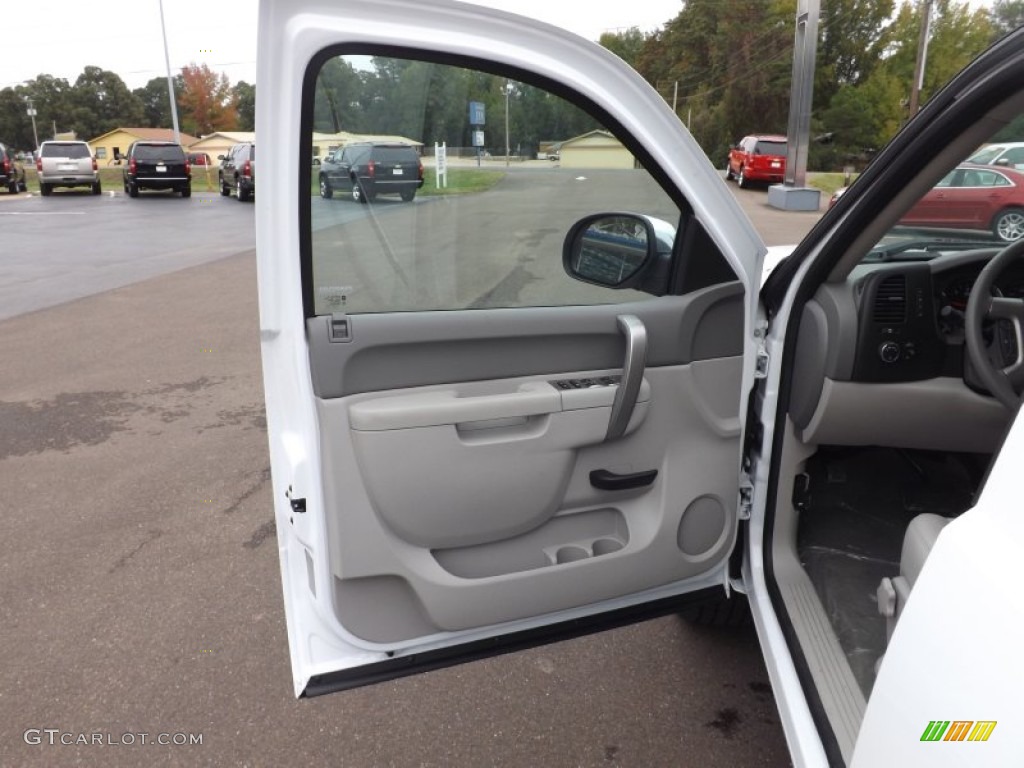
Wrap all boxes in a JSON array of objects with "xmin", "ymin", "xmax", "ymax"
[{"xmin": 964, "ymin": 240, "xmax": 1024, "ymax": 411}]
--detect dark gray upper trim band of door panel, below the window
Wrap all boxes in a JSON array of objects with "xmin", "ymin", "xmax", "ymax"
[{"xmin": 306, "ymin": 282, "xmax": 743, "ymax": 399}]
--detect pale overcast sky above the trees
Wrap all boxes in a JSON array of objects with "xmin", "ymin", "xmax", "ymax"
[{"xmin": 0, "ymin": 0, "xmax": 682, "ymax": 88}]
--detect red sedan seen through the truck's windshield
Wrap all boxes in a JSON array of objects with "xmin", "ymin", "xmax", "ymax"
[{"xmin": 899, "ymin": 165, "xmax": 1024, "ymax": 243}]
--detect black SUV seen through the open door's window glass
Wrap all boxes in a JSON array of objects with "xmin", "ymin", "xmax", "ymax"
[{"xmin": 319, "ymin": 142, "xmax": 423, "ymax": 203}]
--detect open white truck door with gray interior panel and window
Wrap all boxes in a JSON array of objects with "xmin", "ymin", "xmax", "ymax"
[{"xmin": 257, "ymin": 0, "xmax": 765, "ymax": 695}]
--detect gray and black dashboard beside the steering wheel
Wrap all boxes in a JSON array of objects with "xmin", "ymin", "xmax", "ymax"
[{"xmin": 788, "ymin": 247, "xmax": 1011, "ymax": 453}]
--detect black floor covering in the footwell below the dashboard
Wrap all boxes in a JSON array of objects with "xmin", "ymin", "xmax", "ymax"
[{"xmin": 795, "ymin": 447, "xmax": 987, "ymax": 697}]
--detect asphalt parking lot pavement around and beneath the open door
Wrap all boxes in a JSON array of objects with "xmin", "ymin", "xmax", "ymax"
[{"xmin": 0, "ymin": 179, "xmax": 816, "ymax": 766}]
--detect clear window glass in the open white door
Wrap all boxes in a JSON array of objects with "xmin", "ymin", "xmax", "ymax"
[{"xmin": 306, "ymin": 55, "xmax": 680, "ymax": 314}]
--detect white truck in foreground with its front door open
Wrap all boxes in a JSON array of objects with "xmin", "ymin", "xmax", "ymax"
[{"xmin": 262, "ymin": 0, "xmax": 1024, "ymax": 768}]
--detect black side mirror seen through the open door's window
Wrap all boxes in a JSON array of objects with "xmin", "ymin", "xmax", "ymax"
[{"xmin": 562, "ymin": 213, "xmax": 676, "ymax": 296}]
